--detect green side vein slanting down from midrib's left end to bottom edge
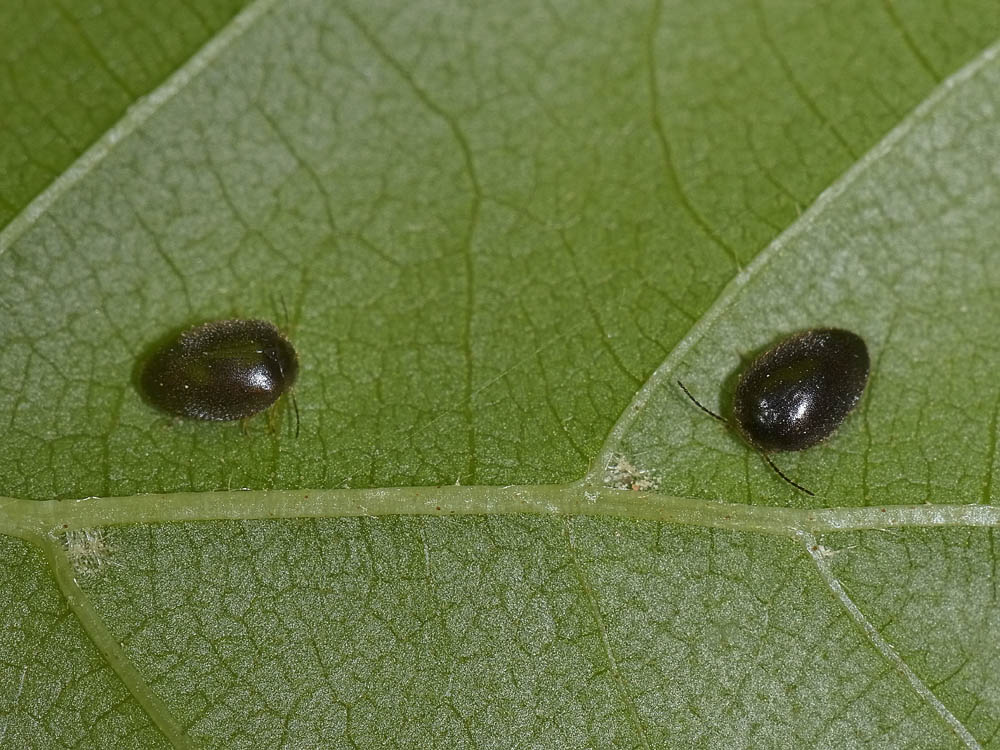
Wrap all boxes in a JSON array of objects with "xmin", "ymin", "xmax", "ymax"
[{"xmin": 37, "ymin": 534, "xmax": 195, "ymax": 750}]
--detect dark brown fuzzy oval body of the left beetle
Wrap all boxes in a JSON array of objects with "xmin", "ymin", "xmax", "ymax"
[{"xmin": 141, "ymin": 319, "xmax": 299, "ymax": 421}]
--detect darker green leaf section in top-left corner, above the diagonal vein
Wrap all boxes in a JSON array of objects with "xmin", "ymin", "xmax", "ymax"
[{"xmin": 0, "ymin": 0, "xmax": 249, "ymax": 226}]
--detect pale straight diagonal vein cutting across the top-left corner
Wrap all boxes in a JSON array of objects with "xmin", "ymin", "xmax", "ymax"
[{"xmin": 0, "ymin": 0, "xmax": 276, "ymax": 255}]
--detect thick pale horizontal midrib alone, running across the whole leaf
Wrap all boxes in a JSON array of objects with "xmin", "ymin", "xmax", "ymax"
[{"xmin": 0, "ymin": 484, "xmax": 1000, "ymax": 541}]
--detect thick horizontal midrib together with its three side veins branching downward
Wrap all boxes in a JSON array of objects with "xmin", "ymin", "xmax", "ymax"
[{"xmin": 7, "ymin": 482, "xmax": 1000, "ymax": 748}]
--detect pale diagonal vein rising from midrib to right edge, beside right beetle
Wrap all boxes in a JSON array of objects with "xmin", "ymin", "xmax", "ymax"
[{"xmin": 587, "ymin": 33, "xmax": 1000, "ymax": 482}]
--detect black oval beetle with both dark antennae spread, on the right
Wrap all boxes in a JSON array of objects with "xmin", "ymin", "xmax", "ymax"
[{"xmin": 677, "ymin": 328, "xmax": 870, "ymax": 495}]
